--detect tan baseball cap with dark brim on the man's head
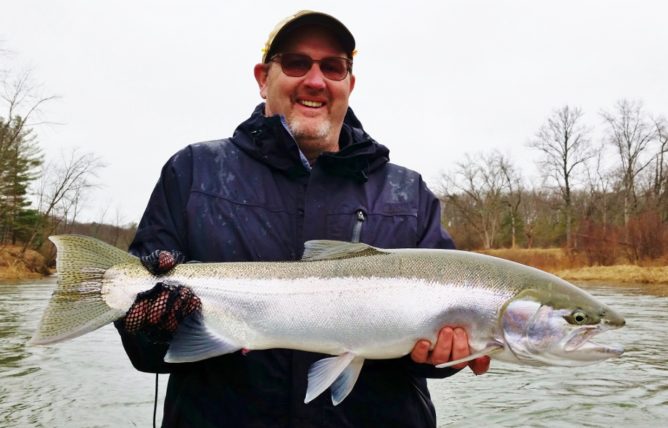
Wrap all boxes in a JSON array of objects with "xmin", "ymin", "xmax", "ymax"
[{"xmin": 262, "ymin": 10, "xmax": 355, "ymax": 63}]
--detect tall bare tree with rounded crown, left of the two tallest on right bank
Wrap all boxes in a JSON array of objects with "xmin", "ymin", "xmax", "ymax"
[{"xmin": 529, "ymin": 106, "xmax": 594, "ymax": 249}]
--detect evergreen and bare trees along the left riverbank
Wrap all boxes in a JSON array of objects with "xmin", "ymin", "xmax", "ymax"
[{"xmin": 0, "ymin": 52, "xmax": 134, "ymax": 257}]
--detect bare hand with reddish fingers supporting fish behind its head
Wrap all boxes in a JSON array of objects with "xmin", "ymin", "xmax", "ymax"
[{"xmin": 411, "ymin": 327, "xmax": 490, "ymax": 375}]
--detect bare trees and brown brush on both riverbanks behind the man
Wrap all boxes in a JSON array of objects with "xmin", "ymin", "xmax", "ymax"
[{"xmin": 0, "ymin": 40, "xmax": 668, "ymax": 282}]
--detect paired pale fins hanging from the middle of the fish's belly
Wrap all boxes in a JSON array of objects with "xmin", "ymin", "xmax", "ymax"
[{"xmin": 304, "ymin": 352, "xmax": 364, "ymax": 405}]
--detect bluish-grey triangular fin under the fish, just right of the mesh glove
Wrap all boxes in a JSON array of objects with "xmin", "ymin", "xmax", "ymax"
[{"xmin": 165, "ymin": 313, "xmax": 242, "ymax": 363}]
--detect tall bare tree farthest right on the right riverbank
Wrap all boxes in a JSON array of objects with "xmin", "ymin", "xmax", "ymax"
[{"xmin": 602, "ymin": 100, "xmax": 657, "ymax": 225}]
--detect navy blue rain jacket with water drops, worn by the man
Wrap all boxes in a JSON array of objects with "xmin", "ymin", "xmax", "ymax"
[{"xmin": 117, "ymin": 104, "xmax": 456, "ymax": 428}]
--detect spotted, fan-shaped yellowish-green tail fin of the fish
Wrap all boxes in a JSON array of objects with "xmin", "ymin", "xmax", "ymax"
[{"xmin": 29, "ymin": 235, "xmax": 137, "ymax": 345}]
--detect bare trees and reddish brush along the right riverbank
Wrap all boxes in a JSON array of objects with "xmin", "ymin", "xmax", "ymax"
[{"xmin": 439, "ymin": 99, "xmax": 668, "ymax": 265}]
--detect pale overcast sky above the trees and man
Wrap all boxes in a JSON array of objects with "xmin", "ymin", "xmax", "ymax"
[{"xmin": 0, "ymin": 0, "xmax": 668, "ymax": 223}]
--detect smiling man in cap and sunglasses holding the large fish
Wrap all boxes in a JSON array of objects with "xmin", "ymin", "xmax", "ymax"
[{"xmin": 117, "ymin": 11, "xmax": 489, "ymax": 427}]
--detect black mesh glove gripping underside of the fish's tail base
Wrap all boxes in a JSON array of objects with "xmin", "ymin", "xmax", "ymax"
[{"xmin": 122, "ymin": 282, "xmax": 202, "ymax": 343}]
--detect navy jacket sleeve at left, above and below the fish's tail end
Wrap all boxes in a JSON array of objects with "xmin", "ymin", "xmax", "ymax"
[{"xmin": 114, "ymin": 148, "xmax": 192, "ymax": 373}]
